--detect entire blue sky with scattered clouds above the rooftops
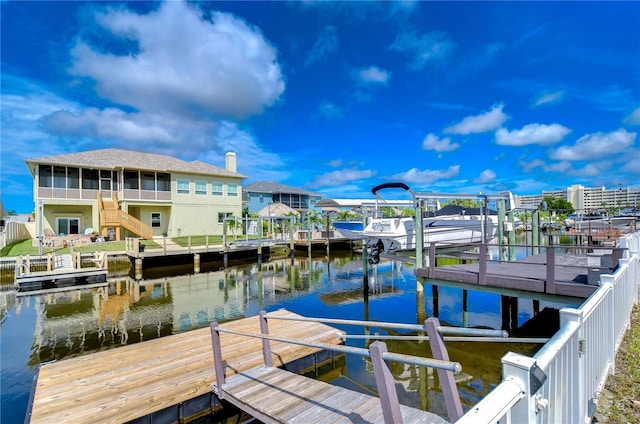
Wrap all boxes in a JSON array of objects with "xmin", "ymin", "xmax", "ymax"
[{"xmin": 0, "ymin": 1, "xmax": 640, "ymax": 212}]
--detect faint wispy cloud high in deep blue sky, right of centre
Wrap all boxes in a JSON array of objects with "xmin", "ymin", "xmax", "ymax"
[{"xmin": 390, "ymin": 31, "xmax": 455, "ymax": 71}]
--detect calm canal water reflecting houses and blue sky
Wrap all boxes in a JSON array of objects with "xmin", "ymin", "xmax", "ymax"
[{"xmin": 0, "ymin": 247, "xmax": 576, "ymax": 423}]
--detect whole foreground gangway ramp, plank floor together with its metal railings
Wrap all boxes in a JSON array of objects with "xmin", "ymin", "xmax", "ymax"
[{"xmin": 211, "ymin": 311, "xmax": 464, "ymax": 424}]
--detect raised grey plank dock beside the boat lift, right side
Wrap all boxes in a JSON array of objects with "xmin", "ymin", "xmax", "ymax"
[{"xmin": 416, "ymin": 254, "xmax": 598, "ymax": 298}]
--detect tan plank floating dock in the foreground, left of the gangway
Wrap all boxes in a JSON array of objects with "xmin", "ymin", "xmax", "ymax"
[{"xmin": 25, "ymin": 310, "xmax": 340, "ymax": 423}]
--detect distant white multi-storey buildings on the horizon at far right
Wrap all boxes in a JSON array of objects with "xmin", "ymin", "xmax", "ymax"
[{"xmin": 516, "ymin": 184, "xmax": 640, "ymax": 211}]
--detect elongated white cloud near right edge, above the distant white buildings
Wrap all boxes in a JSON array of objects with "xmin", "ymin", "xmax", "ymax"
[{"xmin": 549, "ymin": 129, "xmax": 637, "ymax": 161}]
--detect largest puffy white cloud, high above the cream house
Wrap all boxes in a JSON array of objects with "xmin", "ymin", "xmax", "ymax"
[{"xmin": 70, "ymin": 2, "xmax": 285, "ymax": 119}]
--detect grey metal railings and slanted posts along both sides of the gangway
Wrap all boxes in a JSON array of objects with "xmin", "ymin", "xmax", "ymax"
[{"xmin": 211, "ymin": 311, "xmax": 507, "ymax": 423}]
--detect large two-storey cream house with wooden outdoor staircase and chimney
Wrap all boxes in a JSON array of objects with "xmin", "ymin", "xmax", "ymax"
[{"xmin": 26, "ymin": 149, "xmax": 246, "ymax": 239}]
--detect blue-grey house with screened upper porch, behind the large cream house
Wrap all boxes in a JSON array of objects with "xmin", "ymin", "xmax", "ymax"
[{"xmin": 242, "ymin": 181, "xmax": 322, "ymax": 214}]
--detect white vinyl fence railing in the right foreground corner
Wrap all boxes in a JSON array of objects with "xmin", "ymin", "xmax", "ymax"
[{"xmin": 456, "ymin": 232, "xmax": 640, "ymax": 424}]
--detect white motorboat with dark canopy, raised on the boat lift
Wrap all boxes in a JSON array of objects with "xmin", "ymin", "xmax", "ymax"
[{"xmin": 361, "ymin": 183, "xmax": 498, "ymax": 254}]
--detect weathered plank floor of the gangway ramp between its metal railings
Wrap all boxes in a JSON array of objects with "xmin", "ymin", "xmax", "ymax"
[{"xmin": 222, "ymin": 366, "xmax": 447, "ymax": 424}]
